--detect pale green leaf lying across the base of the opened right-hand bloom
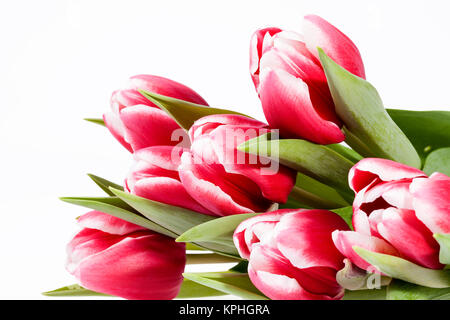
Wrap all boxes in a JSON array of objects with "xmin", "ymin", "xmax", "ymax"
[{"xmin": 353, "ymin": 246, "xmax": 450, "ymax": 288}]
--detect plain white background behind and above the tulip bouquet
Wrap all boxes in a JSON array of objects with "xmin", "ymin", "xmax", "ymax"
[{"xmin": 0, "ymin": 0, "xmax": 450, "ymax": 299}]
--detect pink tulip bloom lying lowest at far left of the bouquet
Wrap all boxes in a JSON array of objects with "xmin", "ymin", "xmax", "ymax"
[{"xmin": 66, "ymin": 211, "xmax": 186, "ymax": 300}]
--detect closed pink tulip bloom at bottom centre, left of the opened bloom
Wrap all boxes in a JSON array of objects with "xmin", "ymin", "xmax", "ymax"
[{"xmin": 233, "ymin": 209, "xmax": 349, "ymax": 300}]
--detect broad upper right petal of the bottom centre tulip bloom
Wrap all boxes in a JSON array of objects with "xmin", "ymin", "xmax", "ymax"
[{"xmin": 274, "ymin": 210, "xmax": 350, "ymax": 271}]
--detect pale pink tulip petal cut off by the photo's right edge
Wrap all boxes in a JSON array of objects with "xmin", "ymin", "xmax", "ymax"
[{"xmin": 410, "ymin": 173, "xmax": 450, "ymax": 234}]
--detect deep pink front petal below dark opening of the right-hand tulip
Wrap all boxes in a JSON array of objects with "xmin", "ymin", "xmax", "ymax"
[{"xmin": 378, "ymin": 208, "xmax": 443, "ymax": 269}]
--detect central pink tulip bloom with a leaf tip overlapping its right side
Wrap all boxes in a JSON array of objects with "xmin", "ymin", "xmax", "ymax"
[{"xmin": 179, "ymin": 115, "xmax": 296, "ymax": 216}]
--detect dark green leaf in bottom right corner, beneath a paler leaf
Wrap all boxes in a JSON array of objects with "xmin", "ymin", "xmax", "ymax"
[{"xmin": 387, "ymin": 279, "xmax": 450, "ymax": 300}]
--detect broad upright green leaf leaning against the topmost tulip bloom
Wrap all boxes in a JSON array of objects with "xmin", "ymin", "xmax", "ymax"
[{"xmin": 318, "ymin": 48, "xmax": 421, "ymax": 168}]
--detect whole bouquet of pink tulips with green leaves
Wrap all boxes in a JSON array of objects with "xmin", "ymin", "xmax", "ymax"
[{"xmin": 46, "ymin": 15, "xmax": 450, "ymax": 300}]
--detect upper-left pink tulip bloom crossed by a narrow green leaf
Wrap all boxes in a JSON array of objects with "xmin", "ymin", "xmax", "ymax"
[{"xmin": 103, "ymin": 75, "xmax": 208, "ymax": 152}]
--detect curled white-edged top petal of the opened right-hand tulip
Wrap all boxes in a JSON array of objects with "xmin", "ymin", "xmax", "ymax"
[{"xmin": 348, "ymin": 158, "xmax": 426, "ymax": 192}]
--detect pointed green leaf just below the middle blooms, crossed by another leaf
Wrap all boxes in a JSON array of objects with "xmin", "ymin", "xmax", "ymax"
[{"xmin": 110, "ymin": 188, "xmax": 239, "ymax": 257}]
